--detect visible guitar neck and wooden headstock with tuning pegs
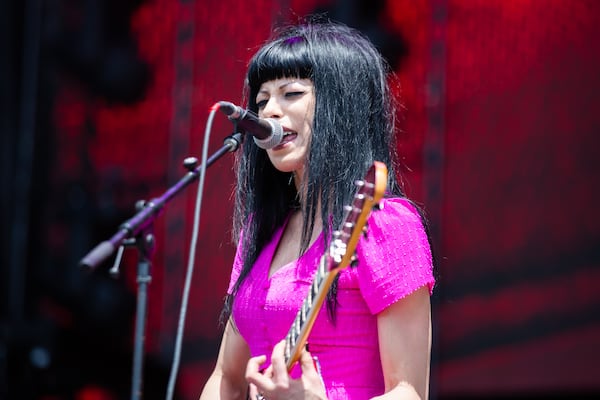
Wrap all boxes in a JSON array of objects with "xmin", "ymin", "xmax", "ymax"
[{"xmin": 284, "ymin": 161, "xmax": 387, "ymax": 372}]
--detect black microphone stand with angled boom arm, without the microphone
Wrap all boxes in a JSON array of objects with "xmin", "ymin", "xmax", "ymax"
[{"xmin": 79, "ymin": 132, "xmax": 243, "ymax": 400}]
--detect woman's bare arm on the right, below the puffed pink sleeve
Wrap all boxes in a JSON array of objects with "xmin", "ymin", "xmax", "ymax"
[{"xmin": 374, "ymin": 286, "xmax": 431, "ymax": 400}]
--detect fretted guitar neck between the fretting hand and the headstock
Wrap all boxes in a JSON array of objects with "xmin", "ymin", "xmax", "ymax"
[{"xmin": 284, "ymin": 255, "xmax": 339, "ymax": 372}]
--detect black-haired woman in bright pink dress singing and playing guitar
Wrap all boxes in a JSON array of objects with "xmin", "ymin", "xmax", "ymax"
[{"xmin": 200, "ymin": 21, "xmax": 435, "ymax": 400}]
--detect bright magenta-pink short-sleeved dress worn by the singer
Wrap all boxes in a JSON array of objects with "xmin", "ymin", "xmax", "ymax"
[{"xmin": 229, "ymin": 198, "xmax": 435, "ymax": 400}]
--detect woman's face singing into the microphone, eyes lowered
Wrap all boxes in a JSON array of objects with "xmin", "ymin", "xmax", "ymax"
[{"xmin": 256, "ymin": 78, "xmax": 315, "ymax": 177}]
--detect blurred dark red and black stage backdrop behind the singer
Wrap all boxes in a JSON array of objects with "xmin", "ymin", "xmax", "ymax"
[{"xmin": 0, "ymin": 0, "xmax": 600, "ymax": 400}]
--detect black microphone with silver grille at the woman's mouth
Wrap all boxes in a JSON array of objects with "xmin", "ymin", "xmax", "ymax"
[{"xmin": 219, "ymin": 101, "xmax": 283, "ymax": 149}]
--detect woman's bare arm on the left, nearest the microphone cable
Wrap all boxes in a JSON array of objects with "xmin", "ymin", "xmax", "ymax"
[{"xmin": 200, "ymin": 319, "xmax": 250, "ymax": 400}]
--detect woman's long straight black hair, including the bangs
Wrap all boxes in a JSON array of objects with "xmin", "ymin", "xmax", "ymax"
[{"xmin": 222, "ymin": 21, "xmax": 403, "ymax": 324}]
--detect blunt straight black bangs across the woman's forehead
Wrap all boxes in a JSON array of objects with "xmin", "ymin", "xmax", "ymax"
[{"xmin": 247, "ymin": 36, "xmax": 313, "ymax": 112}]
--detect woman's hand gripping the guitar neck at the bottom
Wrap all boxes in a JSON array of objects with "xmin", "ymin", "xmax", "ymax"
[{"xmin": 246, "ymin": 341, "xmax": 327, "ymax": 400}]
